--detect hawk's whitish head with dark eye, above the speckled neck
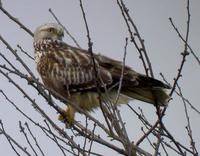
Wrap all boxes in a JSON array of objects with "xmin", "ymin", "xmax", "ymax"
[{"xmin": 34, "ymin": 23, "xmax": 64, "ymax": 41}]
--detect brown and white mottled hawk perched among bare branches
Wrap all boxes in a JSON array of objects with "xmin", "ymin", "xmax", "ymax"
[{"xmin": 33, "ymin": 23, "xmax": 169, "ymax": 124}]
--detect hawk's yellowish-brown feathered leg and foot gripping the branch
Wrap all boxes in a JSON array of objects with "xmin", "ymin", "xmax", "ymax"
[{"xmin": 58, "ymin": 106, "xmax": 75, "ymax": 128}]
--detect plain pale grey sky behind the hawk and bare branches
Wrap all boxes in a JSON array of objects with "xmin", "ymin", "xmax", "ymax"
[{"xmin": 0, "ymin": 0, "xmax": 200, "ymax": 156}]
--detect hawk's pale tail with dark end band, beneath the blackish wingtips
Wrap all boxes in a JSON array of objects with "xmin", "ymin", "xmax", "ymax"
[{"xmin": 122, "ymin": 88, "xmax": 169, "ymax": 106}]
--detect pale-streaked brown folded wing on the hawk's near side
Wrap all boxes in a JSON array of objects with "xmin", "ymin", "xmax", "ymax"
[{"xmin": 37, "ymin": 41, "xmax": 112, "ymax": 94}]
